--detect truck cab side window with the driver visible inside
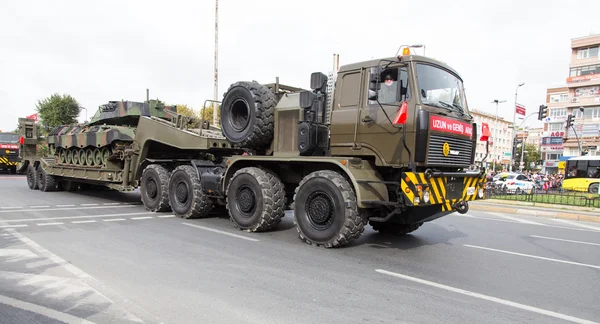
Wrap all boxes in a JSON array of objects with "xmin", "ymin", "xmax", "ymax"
[{"xmin": 369, "ymin": 67, "xmax": 410, "ymax": 105}]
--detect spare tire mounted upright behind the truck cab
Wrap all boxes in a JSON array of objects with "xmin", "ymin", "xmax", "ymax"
[{"xmin": 221, "ymin": 81, "xmax": 277, "ymax": 150}]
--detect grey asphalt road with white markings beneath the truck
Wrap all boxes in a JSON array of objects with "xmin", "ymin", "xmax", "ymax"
[{"xmin": 0, "ymin": 175, "xmax": 600, "ymax": 323}]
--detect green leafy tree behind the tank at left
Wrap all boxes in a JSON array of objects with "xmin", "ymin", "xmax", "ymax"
[{"xmin": 36, "ymin": 93, "xmax": 81, "ymax": 129}]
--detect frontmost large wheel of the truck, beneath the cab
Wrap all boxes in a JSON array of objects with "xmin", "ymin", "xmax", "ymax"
[{"xmin": 294, "ymin": 170, "xmax": 365, "ymax": 248}]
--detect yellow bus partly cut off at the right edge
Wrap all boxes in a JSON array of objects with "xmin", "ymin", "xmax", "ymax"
[{"xmin": 562, "ymin": 156, "xmax": 600, "ymax": 194}]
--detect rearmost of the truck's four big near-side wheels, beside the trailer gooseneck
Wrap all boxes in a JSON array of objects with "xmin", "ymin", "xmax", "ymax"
[{"xmin": 140, "ymin": 164, "xmax": 171, "ymax": 212}]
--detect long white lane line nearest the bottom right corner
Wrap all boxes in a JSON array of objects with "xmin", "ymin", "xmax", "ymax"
[{"xmin": 375, "ymin": 269, "xmax": 597, "ymax": 324}]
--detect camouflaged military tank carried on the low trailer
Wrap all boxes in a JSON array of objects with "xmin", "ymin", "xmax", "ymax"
[{"xmin": 47, "ymin": 100, "xmax": 177, "ymax": 169}]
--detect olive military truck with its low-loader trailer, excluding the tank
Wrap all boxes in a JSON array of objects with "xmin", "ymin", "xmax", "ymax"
[{"xmin": 21, "ymin": 49, "xmax": 485, "ymax": 248}]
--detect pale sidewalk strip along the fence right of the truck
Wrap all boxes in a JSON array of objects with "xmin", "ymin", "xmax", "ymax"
[{"xmin": 469, "ymin": 199, "xmax": 600, "ymax": 223}]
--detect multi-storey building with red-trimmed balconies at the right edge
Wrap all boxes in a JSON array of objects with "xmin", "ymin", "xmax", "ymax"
[{"xmin": 541, "ymin": 34, "xmax": 600, "ymax": 173}]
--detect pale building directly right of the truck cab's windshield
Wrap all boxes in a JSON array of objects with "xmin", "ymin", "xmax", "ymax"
[{"xmin": 470, "ymin": 109, "xmax": 513, "ymax": 171}]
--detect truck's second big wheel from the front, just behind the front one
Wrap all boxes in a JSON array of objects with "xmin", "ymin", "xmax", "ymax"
[{"xmin": 227, "ymin": 167, "xmax": 285, "ymax": 232}]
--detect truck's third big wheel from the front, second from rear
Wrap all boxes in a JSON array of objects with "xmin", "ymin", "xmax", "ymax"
[{"xmin": 169, "ymin": 165, "xmax": 212, "ymax": 218}]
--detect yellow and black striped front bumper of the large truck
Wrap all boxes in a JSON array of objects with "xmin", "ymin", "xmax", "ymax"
[{"xmin": 400, "ymin": 172, "xmax": 485, "ymax": 211}]
